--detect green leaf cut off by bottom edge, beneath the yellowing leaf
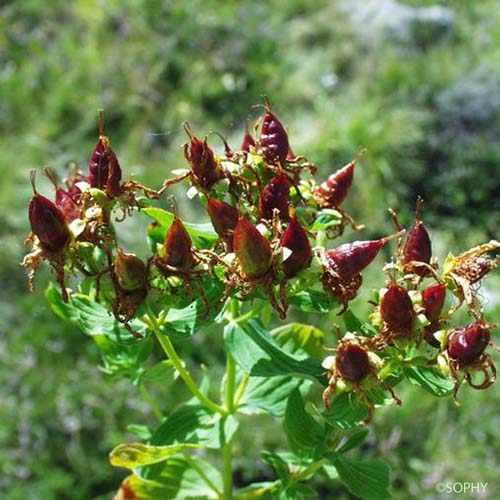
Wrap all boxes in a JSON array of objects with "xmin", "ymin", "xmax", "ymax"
[{"xmin": 128, "ymin": 455, "xmax": 222, "ymax": 500}]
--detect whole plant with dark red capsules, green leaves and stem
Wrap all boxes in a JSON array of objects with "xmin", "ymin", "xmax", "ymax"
[{"xmin": 23, "ymin": 100, "xmax": 500, "ymax": 499}]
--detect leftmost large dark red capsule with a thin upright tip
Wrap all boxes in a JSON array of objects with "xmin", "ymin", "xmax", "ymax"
[{"xmin": 28, "ymin": 170, "xmax": 71, "ymax": 252}]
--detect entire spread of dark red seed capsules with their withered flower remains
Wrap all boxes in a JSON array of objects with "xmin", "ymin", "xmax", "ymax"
[{"xmin": 23, "ymin": 99, "xmax": 500, "ymax": 421}]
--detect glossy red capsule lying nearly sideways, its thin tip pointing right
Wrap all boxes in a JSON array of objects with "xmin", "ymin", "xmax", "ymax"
[{"xmin": 326, "ymin": 233, "xmax": 401, "ymax": 280}]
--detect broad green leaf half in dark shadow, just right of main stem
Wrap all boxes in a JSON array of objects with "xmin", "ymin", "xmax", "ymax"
[{"xmin": 224, "ymin": 319, "xmax": 326, "ymax": 384}]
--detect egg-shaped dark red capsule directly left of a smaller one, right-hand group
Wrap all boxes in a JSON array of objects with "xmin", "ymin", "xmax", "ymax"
[{"xmin": 380, "ymin": 285, "xmax": 415, "ymax": 332}]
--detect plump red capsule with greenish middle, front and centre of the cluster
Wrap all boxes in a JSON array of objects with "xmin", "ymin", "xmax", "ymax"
[{"xmin": 233, "ymin": 217, "xmax": 273, "ymax": 278}]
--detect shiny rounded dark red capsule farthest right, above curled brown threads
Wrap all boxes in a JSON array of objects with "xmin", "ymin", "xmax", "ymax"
[{"xmin": 447, "ymin": 322, "xmax": 491, "ymax": 366}]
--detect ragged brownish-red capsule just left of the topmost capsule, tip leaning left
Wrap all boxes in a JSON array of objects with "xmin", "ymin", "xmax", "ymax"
[{"xmin": 184, "ymin": 124, "xmax": 222, "ymax": 189}]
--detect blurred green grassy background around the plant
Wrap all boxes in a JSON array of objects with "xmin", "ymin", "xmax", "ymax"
[{"xmin": 0, "ymin": 0, "xmax": 500, "ymax": 500}]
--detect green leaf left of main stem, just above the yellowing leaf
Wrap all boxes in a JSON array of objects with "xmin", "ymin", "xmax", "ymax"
[{"xmin": 151, "ymin": 404, "xmax": 238, "ymax": 448}]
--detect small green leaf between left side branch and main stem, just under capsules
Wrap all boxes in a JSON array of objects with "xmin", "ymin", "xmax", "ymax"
[{"xmin": 160, "ymin": 281, "xmax": 224, "ymax": 340}]
